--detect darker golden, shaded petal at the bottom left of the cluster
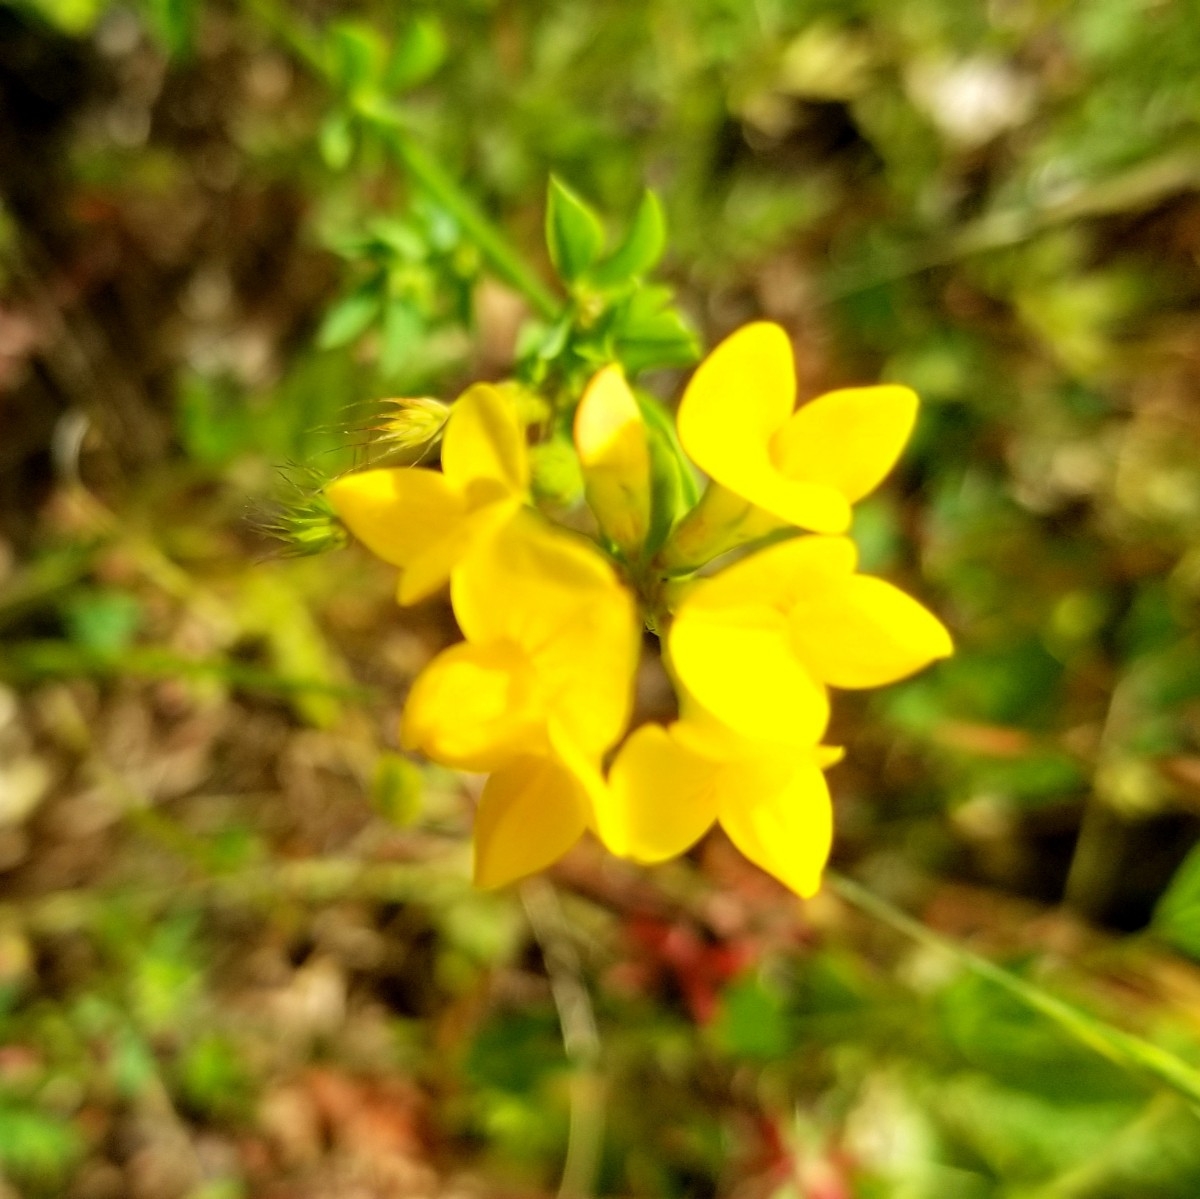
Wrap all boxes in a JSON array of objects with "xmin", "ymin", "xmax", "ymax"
[{"xmin": 475, "ymin": 756, "xmax": 588, "ymax": 887}]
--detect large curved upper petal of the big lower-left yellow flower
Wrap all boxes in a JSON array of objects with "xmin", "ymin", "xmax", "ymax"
[{"xmin": 451, "ymin": 514, "xmax": 641, "ymax": 754}]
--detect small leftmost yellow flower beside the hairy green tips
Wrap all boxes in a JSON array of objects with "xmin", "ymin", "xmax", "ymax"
[{"xmin": 325, "ymin": 384, "xmax": 529, "ymax": 604}]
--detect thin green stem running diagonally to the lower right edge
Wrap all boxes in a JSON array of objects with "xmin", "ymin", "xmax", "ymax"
[{"xmin": 826, "ymin": 871, "xmax": 1200, "ymax": 1115}]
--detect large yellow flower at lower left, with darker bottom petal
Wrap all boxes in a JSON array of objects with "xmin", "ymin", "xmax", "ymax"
[{"xmin": 401, "ymin": 514, "xmax": 640, "ymax": 887}]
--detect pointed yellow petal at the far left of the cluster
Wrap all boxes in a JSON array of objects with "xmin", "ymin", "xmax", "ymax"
[{"xmin": 325, "ymin": 467, "xmax": 467, "ymax": 569}]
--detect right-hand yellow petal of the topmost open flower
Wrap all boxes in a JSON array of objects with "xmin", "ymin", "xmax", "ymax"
[{"xmin": 772, "ymin": 385, "xmax": 917, "ymax": 504}]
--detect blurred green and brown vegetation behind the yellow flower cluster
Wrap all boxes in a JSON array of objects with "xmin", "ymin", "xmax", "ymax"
[{"xmin": 7, "ymin": 0, "xmax": 1200, "ymax": 1199}]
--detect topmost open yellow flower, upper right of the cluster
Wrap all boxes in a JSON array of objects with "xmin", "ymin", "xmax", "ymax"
[{"xmin": 677, "ymin": 322, "xmax": 917, "ymax": 533}]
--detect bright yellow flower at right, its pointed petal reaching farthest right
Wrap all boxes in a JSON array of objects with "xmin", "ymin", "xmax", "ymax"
[{"xmin": 668, "ymin": 536, "xmax": 953, "ymax": 744}]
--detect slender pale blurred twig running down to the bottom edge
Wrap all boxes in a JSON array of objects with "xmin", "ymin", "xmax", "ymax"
[{"xmin": 521, "ymin": 877, "xmax": 605, "ymax": 1199}]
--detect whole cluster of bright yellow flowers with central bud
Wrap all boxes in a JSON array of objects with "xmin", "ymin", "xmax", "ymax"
[{"xmin": 326, "ymin": 323, "xmax": 952, "ymax": 895}]
